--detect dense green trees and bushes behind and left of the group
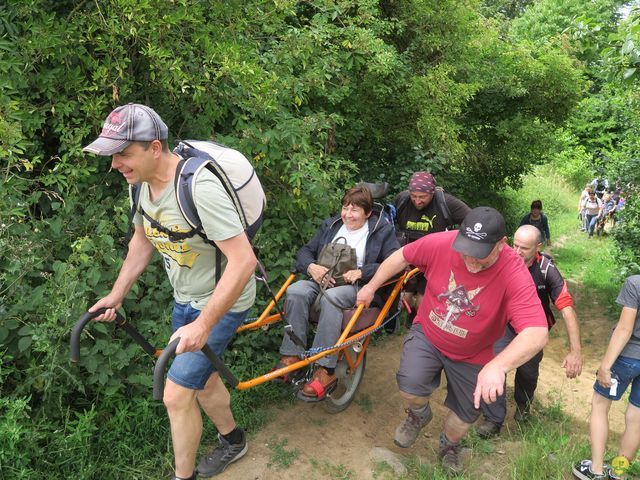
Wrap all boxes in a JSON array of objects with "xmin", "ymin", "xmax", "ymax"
[{"xmin": 0, "ymin": 0, "xmax": 640, "ymax": 479}]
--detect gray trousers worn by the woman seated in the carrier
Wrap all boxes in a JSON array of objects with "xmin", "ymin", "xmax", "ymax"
[{"xmin": 280, "ymin": 280, "xmax": 357, "ymax": 368}]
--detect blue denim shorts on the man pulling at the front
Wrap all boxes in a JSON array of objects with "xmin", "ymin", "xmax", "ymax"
[{"xmin": 167, "ymin": 302, "xmax": 249, "ymax": 390}]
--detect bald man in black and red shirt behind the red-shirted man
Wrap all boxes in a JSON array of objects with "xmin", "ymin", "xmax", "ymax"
[{"xmin": 476, "ymin": 225, "xmax": 582, "ymax": 438}]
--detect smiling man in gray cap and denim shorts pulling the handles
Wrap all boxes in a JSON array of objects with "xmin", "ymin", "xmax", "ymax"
[{"xmin": 83, "ymin": 103, "xmax": 256, "ymax": 480}]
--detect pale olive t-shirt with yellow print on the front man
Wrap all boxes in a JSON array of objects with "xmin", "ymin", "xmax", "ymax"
[{"xmin": 133, "ymin": 170, "xmax": 256, "ymax": 312}]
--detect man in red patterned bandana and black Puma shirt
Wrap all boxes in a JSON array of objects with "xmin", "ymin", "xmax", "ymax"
[{"xmin": 394, "ymin": 172, "xmax": 471, "ymax": 313}]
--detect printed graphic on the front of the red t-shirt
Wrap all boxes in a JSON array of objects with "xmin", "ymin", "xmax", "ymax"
[{"xmin": 429, "ymin": 271, "xmax": 482, "ymax": 338}]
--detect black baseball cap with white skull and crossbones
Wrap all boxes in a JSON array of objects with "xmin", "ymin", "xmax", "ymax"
[{"xmin": 453, "ymin": 207, "xmax": 506, "ymax": 259}]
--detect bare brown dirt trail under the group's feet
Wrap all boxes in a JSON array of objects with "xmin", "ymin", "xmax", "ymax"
[{"xmin": 220, "ymin": 239, "xmax": 624, "ymax": 480}]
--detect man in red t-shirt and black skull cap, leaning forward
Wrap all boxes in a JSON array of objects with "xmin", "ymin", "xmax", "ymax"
[{"xmin": 357, "ymin": 207, "xmax": 548, "ymax": 472}]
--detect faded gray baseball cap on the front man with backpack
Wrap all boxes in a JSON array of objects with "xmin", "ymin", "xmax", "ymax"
[{"xmin": 82, "ymin": 103, "xmax": 169, "ymax": 156}]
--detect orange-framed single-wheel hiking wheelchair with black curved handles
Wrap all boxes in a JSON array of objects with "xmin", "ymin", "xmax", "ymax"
[{"xmin": 70, "ymin": 182, "xmax": 419, "ymax": 413}]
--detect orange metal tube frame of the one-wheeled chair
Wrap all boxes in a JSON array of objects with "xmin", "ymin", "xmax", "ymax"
[{"xmin": 231, "ymin": 268, "xmax": 419, "ymax": 390}]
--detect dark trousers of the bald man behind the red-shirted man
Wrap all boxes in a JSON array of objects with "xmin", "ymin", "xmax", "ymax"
[{"xmin": 480, "ymin": 327, "xmax": 543, "ymax": 425}]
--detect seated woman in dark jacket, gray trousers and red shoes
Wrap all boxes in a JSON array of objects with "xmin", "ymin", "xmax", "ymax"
[{"xmin": 278, "ymin": 186, "xmax": 400, "ymax": 402}]
